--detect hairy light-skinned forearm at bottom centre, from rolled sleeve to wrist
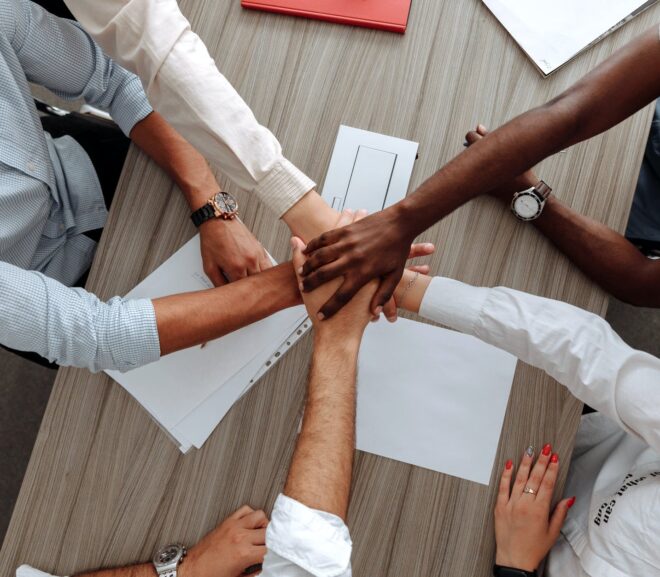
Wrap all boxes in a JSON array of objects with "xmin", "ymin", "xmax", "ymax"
[{"xmin": 284, "ymin": 332, "xmax": 359, "ymax": 520}]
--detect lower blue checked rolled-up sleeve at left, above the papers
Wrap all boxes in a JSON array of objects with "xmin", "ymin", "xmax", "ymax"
[{"xmin": 0, "ymin": 263, "xmax": 160, "ymax": 372}]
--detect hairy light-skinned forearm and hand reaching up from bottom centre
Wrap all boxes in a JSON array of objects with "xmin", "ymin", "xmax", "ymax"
[{"xmin": 284, "ymin": 213, "xmax": 376, "ymax": 520}]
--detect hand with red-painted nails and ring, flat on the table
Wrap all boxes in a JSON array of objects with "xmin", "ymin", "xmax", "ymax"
[{"xmin": 495, "ymin": 444, "xmax": 575, "ymax": 571}]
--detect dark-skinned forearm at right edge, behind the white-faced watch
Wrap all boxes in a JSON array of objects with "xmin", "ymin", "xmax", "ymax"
[{"xmin": 534, "ymin": 197, "xmax": 660, "ymax": 307}]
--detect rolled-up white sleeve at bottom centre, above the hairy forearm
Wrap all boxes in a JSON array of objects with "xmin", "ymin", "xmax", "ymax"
[{"xmin": 261, "ymin": 495, "xmax": 353, "ymax": 577}]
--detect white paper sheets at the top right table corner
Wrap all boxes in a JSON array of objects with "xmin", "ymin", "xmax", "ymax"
[{"xmin": 484, "ymin": 0, "xmax": 657, "ymax": 75}]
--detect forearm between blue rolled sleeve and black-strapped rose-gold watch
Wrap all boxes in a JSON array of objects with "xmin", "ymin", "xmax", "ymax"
[{"xmin": 130, "ymin": 112, "xmax": 219, "ymax": 211}]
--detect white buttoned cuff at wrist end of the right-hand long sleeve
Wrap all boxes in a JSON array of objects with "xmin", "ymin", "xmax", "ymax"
[{"xmin": 419, "ymin": 277, "xmax": 491, "ymax": 335}]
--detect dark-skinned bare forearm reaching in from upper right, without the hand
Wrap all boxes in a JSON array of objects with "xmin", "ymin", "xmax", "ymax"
[{"xmin": 392, "ymin": 28, "xmax": 660, "ymax": 238}]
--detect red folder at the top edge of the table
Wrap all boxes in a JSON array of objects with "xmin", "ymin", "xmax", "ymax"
[{"xmin": 241, "ymin": 0, "xmax": 411, "ymax": 34}]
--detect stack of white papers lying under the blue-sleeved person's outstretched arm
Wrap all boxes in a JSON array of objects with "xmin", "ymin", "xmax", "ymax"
[{"xmin": 108, "ymin": 236, "xmax": 310, "ymax": 452}]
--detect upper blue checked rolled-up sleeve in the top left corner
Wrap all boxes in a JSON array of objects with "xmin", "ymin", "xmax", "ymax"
[{"xmin": 13, "ymin": 0, "xmax": 153, "ymax": 135}]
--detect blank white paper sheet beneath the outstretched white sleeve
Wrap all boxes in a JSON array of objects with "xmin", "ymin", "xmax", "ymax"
[{"xmin": 357, "ymin": 319, "xmax": 517, "ymax": 485}]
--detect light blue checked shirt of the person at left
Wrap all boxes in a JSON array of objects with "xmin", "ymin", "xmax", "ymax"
[{"xmin": 0, "ymin": 0, "xmax": 160, "ymax": 371}]
